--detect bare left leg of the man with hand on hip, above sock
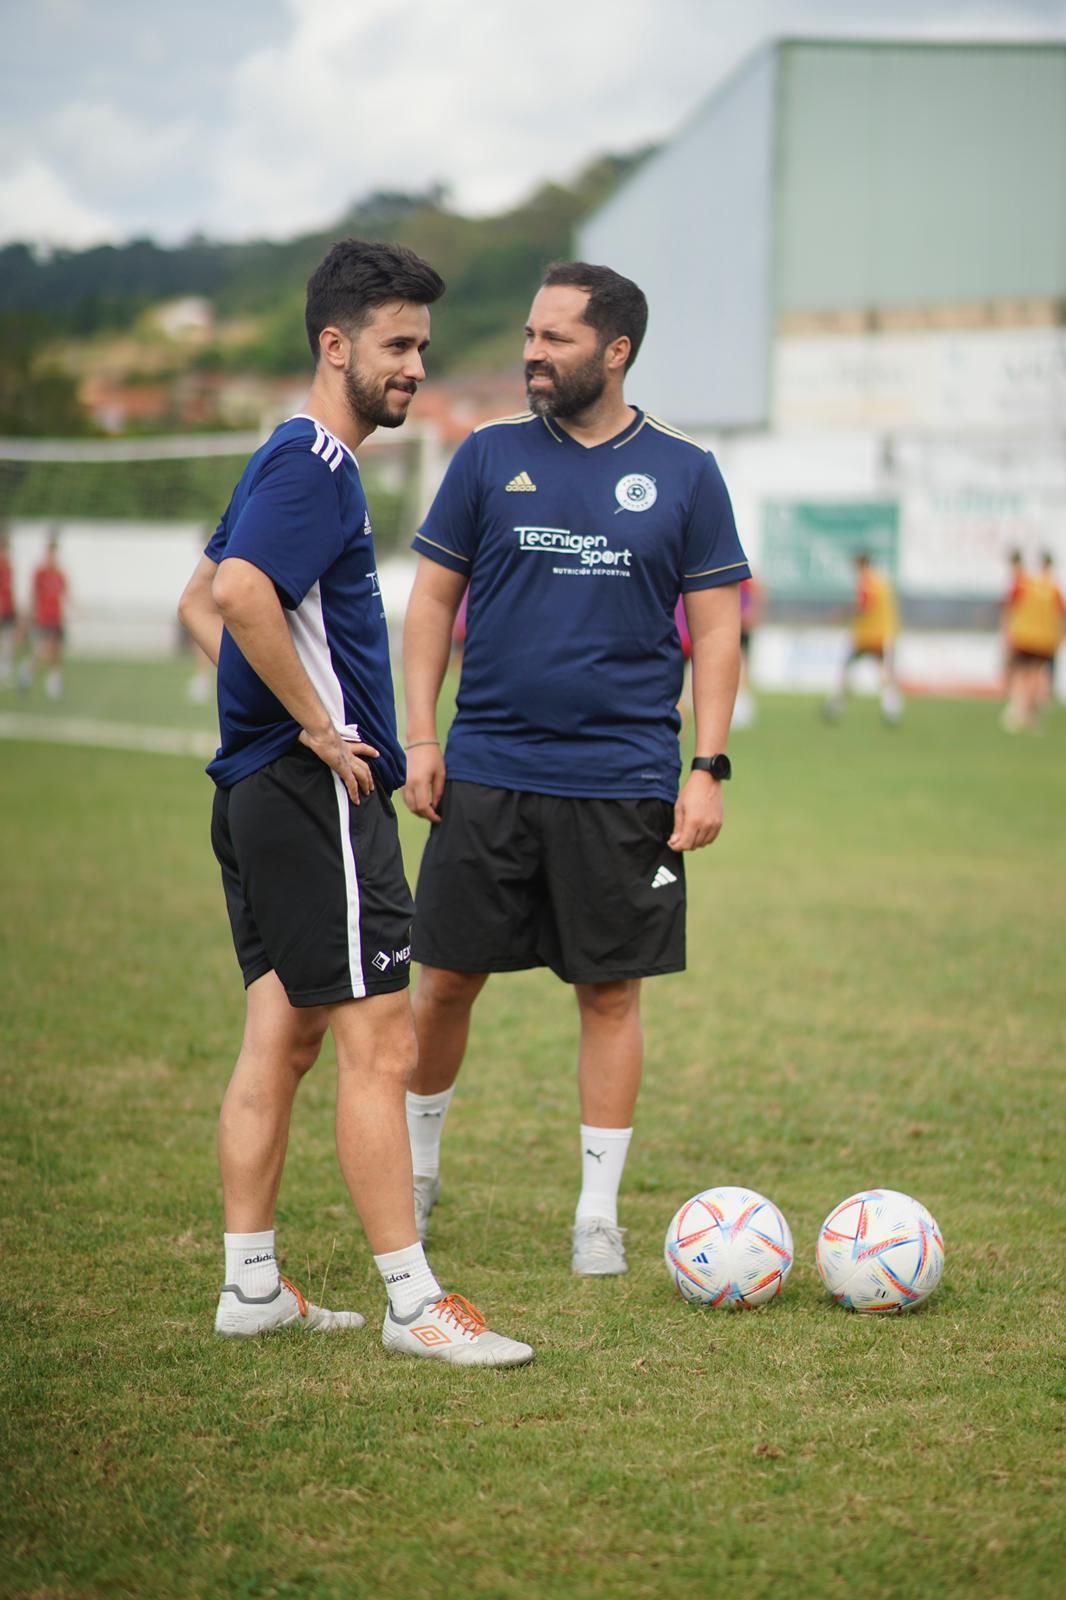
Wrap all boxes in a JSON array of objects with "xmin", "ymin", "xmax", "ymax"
[{"xmin": 218, "ymin": 971, "xmax": 327, "ymax": 1234}]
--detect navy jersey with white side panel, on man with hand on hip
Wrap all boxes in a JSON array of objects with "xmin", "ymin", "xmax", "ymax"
[{"xmin": 206, "ymin": 416, "xmax": 405, "ymax": 790}]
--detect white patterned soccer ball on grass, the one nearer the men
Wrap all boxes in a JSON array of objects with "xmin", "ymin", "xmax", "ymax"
[{"xmin": 663, "ymin": 1186, "xmax": 792, "ymax": 1310}]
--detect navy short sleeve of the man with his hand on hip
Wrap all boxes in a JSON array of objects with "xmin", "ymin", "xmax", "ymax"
[{"xmin": 222, "ymin": 448, "xmax": 344, "ymax": 610}]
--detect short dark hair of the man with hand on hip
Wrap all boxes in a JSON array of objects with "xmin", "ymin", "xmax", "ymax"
[{"xmin": 304, "ymin": 238, "xmax": 445, "ymax": 362}]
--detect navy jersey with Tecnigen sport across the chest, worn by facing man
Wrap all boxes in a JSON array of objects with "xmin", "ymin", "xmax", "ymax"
[{"xmin": 415, "ymin": 411, "xmax": 749, "ymax": 800}]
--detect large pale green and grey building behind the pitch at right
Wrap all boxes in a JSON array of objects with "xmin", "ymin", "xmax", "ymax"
[{"xmin": 576, "ymin": 42, "xmax": 1066, "ymax": 686}]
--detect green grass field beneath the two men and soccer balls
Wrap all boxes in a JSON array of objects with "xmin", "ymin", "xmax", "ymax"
[{"xmin": 0, "ymin": 666, "xmax": 1066, "ymax": 1600}]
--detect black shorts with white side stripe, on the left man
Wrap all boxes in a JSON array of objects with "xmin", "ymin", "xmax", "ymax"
[{"xmin": 211, "ymin": 746, "xmax": 415, "ymax": 1006}]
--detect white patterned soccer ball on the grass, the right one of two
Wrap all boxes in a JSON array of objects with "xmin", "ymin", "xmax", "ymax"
[{"xmin": 815, "ymin": 1189, "xmax": 944, "ymax": 1312}]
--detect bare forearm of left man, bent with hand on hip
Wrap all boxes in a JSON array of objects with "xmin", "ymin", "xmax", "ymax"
[{"xmin": 214, "ymin": 562, "xmax": 333, "ymax": 738}]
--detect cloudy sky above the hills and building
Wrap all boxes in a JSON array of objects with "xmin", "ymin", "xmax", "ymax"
[{"xmin": 0, "ymin": 0, "xmax": 1066, "ymax": 246}]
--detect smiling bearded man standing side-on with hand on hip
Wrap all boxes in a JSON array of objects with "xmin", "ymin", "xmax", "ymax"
[{"xmin": 179, "ymin": 238, "xmax": 533, "ymax": 1366}]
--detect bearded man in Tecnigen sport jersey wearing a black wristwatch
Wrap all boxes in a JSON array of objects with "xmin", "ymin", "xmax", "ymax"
[{"xmin": 403, "ymin": 261, "xmax": 749, "ymax": 1277}]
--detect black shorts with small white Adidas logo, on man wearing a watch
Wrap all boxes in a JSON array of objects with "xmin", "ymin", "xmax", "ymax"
[{"xmin": 415, "ymin": 779, "xmax": 685, "ymax": 984}]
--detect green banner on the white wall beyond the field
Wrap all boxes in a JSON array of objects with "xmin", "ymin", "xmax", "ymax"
[{"xmin": 759, "ymin": 501, "xmax": 900, "ymax": 600}]
